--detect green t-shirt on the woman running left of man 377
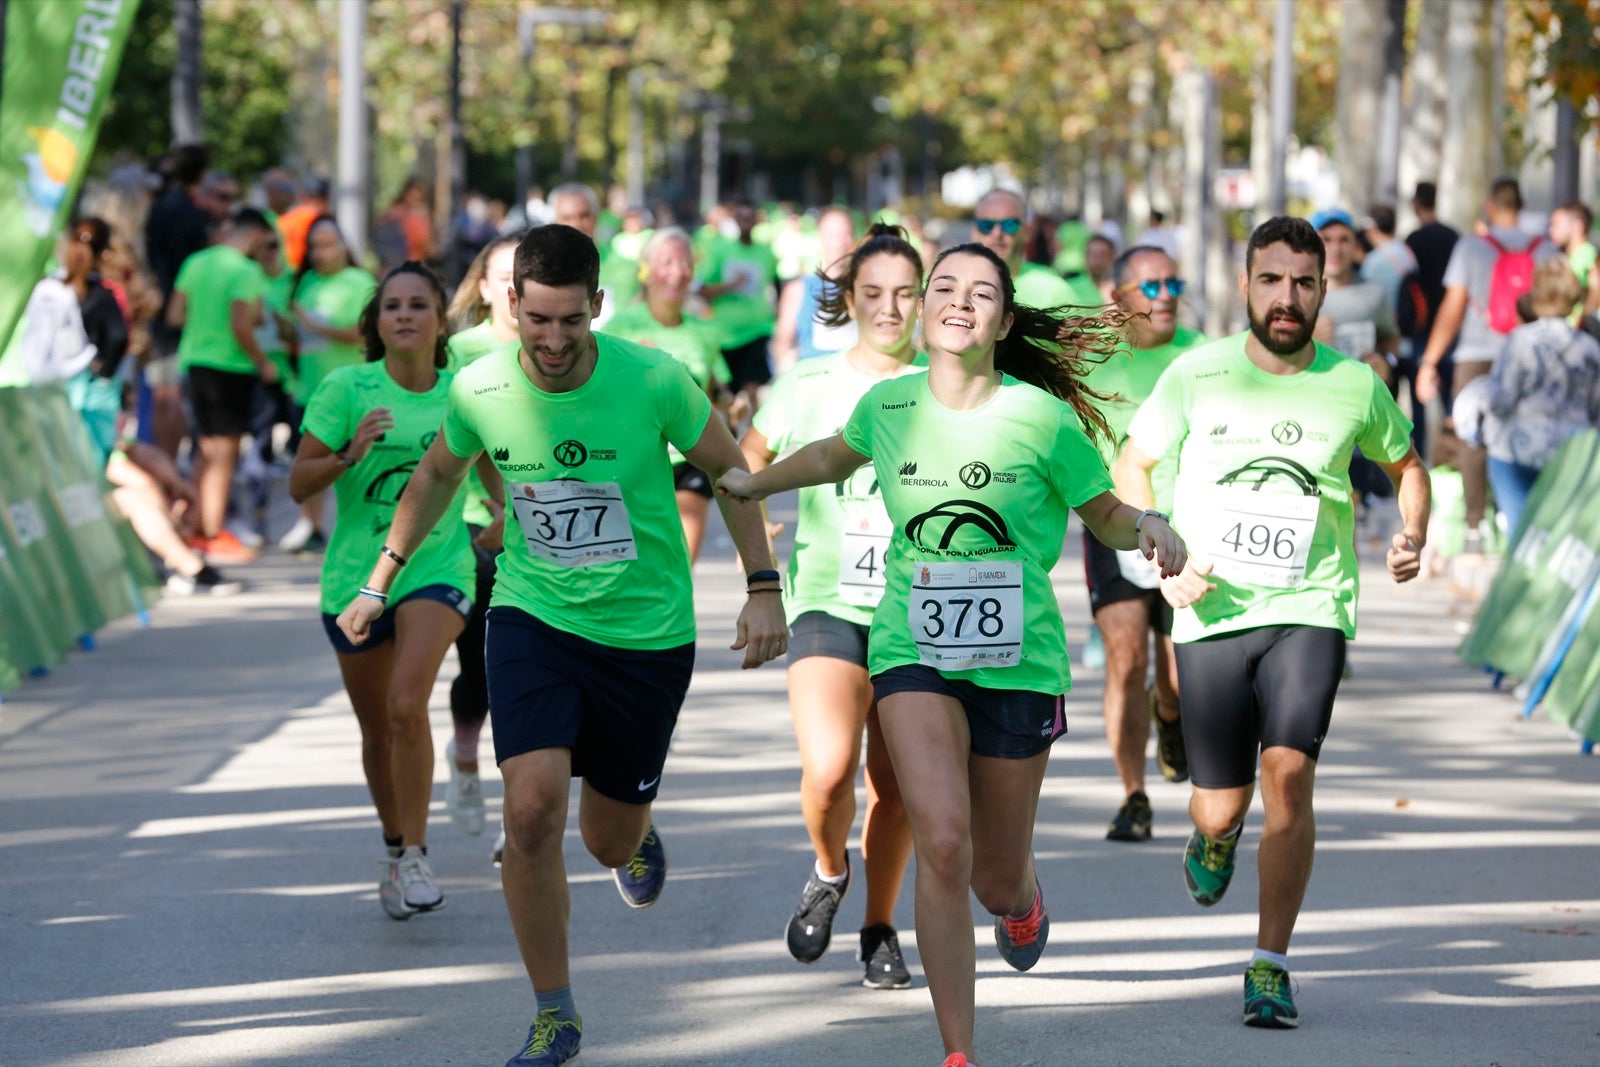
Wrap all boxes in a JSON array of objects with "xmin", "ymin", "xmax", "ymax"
[{"xmin": 301, "ymin": 360, "xmax": 477, "ymax": 614}]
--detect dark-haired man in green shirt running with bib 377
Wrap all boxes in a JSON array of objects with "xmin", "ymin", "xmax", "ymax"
[{"xmin": 339, "ymin": 224, "xmax": 787, "ymax": 1067}]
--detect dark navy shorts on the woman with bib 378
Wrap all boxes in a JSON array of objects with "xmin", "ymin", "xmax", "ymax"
[{"xmin": 872, "ymin": 664, "xmax": 1067, "ymax": 760}]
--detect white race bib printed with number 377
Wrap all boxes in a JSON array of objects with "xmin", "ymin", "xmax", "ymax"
[{"xmin": 507, "ymin": 480, "xmax": 638, "ymax": 566}]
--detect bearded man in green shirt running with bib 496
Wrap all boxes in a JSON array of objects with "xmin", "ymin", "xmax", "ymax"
[{"xmin": 1117, "ymin": 218, "xmax": 1430, "ymax": 1029}]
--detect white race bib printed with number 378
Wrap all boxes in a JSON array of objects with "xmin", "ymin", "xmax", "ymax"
[{"xmin": 907, "ymin": 560, "xmax": 1024, "ymax": 670}]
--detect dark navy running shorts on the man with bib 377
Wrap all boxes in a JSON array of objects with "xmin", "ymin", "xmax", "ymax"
[{"xmin": 483, "ymin": 605, "xmax": 694, "ymax": 805}]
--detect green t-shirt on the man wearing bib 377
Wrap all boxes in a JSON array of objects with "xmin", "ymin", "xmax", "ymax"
[{"xmin": 445, "ymin": 333, "xmax": 712, "ymax": 649}]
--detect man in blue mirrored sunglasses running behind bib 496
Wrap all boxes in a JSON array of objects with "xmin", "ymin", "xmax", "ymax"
[{"xmin": 1083, "ymin": 245, "xmax": 1206, "ymax": 841}]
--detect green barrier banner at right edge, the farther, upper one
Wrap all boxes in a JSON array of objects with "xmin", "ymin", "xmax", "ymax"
[{"xmin": 1458, "ymin": 430, "xmax": 1600, "ymax": 678}]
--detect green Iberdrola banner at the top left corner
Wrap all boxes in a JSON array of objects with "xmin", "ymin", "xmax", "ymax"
[{"xmin": 0, "ymin": 0, "xmax": 139, "ymax": 375}]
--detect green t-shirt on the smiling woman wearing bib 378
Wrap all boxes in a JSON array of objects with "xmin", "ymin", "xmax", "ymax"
[{"xmin": 845, "ymin": 374, "xmax": 1110, "ymax": 694}]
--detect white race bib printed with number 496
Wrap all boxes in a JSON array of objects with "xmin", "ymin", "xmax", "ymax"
[{"xmin": 1190, "ymin": 485, "xmax": 1322, "ymax": 589}]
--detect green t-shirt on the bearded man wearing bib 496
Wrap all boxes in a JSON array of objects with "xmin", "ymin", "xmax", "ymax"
[{"xmin": 1128, "ymin": 333, "xmax": 1411, "ymax": 641}]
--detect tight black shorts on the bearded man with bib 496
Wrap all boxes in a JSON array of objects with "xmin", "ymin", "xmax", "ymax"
[{"xmin": 1178, "ymin": 625, "xmax": 1344, "ymax": 789}]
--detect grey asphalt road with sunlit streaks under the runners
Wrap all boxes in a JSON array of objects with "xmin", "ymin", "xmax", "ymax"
[{"xmin": 0, "ymin": 495, "xmax": 1600, "ymax": 1067}]
